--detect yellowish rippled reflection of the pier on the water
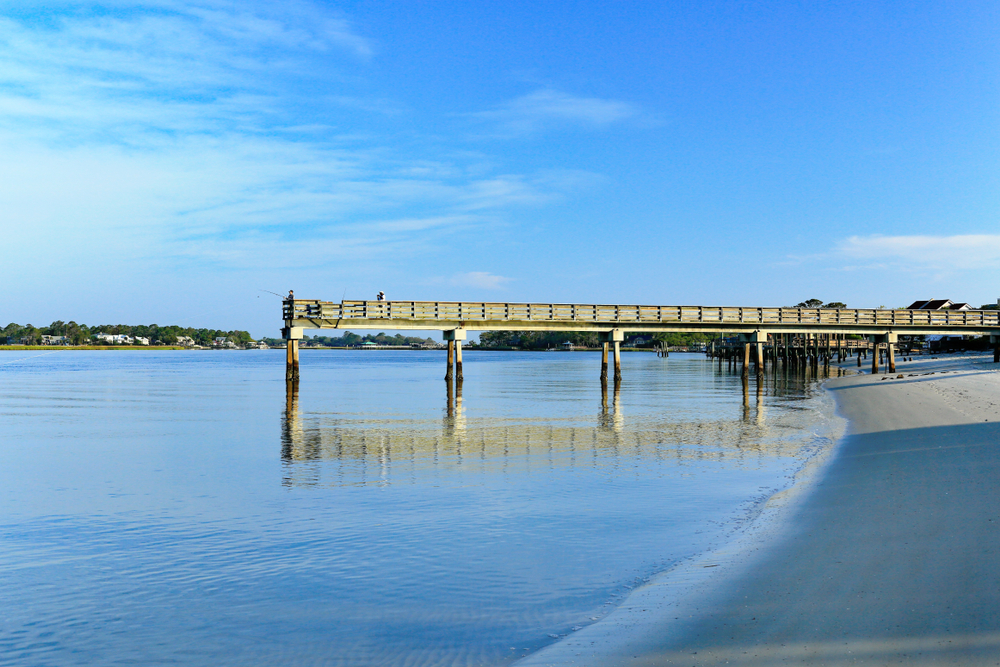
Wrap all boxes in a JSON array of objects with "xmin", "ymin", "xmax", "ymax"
[{"xmin": 281, "ymin": 368, "xmax": 824, "ymax": 486}]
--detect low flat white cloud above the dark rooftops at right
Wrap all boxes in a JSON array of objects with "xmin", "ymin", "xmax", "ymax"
[{"xmin": 836, "ymin": 234, "xmax": 1000, "ymax": 271}]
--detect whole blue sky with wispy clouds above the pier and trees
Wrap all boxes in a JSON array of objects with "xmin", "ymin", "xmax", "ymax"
[{"xmin": 0, "ymin": 0, "xmax": 1000, "ymax": 336}]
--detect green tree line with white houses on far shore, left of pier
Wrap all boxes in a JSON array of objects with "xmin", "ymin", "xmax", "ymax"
[{"xmin": 0, "ymin": 320, "xmax": 253, "ymax": 346}]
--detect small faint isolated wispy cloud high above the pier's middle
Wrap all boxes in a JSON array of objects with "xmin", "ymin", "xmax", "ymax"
[{"xmin": 471, "ymin": 89, "xmax": 639, "ymax": 134}]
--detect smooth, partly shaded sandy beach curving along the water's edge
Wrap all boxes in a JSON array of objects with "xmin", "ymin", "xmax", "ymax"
[{"xmin": 518, "ymin": 354, "xmax": 1000, "ymax": 667}]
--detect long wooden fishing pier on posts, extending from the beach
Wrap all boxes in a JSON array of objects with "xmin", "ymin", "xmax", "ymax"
[{"xmin": 282, "ymin": 299, "xmax": 1000, "ymax": 381}]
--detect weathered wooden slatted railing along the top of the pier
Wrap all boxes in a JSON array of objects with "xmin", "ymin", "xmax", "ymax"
[{"xmin": 283, "ymin": 299, "xmax": 1000, "ymax": 329}]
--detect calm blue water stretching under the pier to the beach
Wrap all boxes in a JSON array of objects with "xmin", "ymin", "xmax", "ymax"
[{"xmin": 0, "ymin": 350, "xmax": 827, "ymax": 666}]
